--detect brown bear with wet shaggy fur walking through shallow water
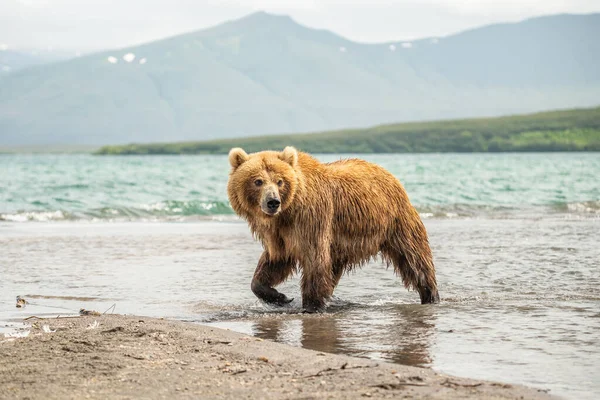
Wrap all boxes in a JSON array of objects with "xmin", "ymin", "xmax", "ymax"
[{"xmin": 227, "ymin": 147, "xmax": 439, "ymax": 312}]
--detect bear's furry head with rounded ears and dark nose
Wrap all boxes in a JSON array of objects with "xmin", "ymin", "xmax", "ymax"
[{"xmin": 227, "ymin": 147, "xmax": 298, "ymax": 218}]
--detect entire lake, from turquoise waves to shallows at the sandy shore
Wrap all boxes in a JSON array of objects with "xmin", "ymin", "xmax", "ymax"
[{"xmin": 0, "ymin": 153, "xmax": 600, "ymax": 399}]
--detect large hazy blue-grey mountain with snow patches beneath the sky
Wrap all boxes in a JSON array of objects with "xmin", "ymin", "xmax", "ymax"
[{"xmin": 0, "ymin": 12, "xmax": 600, "ymax": 145}]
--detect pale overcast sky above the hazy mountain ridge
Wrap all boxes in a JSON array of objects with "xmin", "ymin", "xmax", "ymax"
[{"xmin": 0, "ymin": 0, "xmax": 600, "ymax": 52}]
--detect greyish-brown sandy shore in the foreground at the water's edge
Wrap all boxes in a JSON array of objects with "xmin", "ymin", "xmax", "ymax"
[{"xmin": 0, "ymin": 315, "xmax": 553, "ymax": 399}]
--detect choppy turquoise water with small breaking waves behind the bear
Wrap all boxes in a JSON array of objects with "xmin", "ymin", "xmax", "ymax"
[{"xmin": 0, "ymin": 153, "xmax": 600, "ymax": 221}]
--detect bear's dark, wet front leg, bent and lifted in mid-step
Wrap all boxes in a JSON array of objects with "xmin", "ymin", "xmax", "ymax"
[{"xmin": 250, "ymin": 251, "xmax": 296, "ymax": 306}]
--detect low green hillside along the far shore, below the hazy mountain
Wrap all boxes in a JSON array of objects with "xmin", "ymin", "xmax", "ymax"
[{"xmin": 96, "ymin": 107, "xmax": 600, "ymax": 155}]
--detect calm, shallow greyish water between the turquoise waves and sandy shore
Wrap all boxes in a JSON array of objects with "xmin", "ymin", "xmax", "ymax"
[{"xmin": 0, "ymin": 216, "xmax": 600, "ymax": 399}]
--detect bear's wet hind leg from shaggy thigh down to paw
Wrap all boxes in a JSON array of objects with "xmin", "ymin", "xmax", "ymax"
[{"xmin": 383, "ymin": 207, "xmax": 440, "ymax": 304}]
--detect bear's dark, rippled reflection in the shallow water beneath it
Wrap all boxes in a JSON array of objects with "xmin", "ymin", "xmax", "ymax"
[{"xmin": 253, "ymin": 304, "xmax": 435, "ymax": 367}]
